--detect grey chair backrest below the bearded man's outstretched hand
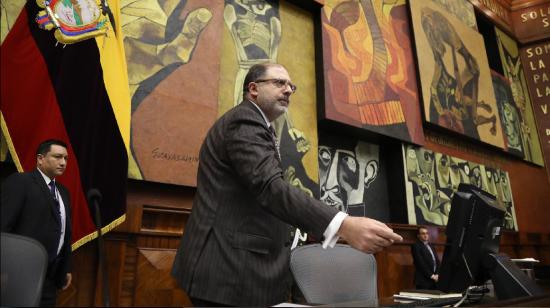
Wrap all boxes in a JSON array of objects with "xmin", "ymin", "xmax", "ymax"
[{"xmin": 290, "ymin": 244, "xmax": 378, "ymax": 305}]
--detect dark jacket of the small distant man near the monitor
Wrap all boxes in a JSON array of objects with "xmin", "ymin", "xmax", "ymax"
[{"xmin": 412, "ymin": 240, "xmax": 439, "ymax": 289}]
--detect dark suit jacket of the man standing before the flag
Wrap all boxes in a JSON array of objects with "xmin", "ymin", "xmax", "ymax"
[{"xmin": 1, "ymin": 169, "xmax": 71, "ymax": 288}]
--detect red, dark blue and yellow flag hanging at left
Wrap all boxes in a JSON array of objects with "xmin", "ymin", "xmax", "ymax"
[{"xmin": 0, "ymin": 0, "xmax": 130, "ymax": 250}]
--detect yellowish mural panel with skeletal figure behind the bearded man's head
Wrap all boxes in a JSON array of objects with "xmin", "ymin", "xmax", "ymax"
[{"xmin": 218, "ymin": 0, "xmax": 319, "ymax": 197}]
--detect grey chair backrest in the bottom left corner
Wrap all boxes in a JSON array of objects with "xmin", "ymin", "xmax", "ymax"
[{"xmin": 0, "ymin": 232, "xmax": 48, "ymax": 307}]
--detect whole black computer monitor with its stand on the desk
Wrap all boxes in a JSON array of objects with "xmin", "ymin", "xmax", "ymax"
[{"xmin": 437, "ymin": 184, "xmax": 543, "ymax": 299}]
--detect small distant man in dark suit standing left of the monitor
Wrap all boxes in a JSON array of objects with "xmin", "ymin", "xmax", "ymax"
[{"xmin": 411, "ymin": 227, "xmax": 439, "ymax": 290}]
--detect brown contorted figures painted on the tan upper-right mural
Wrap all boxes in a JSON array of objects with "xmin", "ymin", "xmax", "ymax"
[{"xmin": 421, "ymin": 7, "xmax": 497, "ymax": 139}]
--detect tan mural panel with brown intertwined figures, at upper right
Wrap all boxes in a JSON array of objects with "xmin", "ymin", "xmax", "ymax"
[{"xmin": 410, "ymin": 0, "xmax": 505, "ymax": 148}]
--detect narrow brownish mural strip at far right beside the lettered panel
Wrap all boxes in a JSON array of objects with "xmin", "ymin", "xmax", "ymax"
[{"xmin": 495, "ymin": 27, "xmax": 544, "ymax": 166}]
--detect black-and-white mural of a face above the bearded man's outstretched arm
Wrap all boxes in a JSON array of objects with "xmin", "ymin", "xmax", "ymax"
[{"xmin": 319, "ymin": 136, "xmax": 390, "ymax": 222}]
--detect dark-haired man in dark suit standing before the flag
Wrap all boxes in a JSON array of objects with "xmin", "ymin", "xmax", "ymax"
[{"xmin": 1, "ymin": 139, "xmax": 72, "ymax": 306}]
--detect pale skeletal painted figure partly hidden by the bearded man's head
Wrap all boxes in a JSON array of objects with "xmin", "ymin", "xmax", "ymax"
[{"xmin": 224, "ymin": 0, "xmax": 317, "ymax": 196}]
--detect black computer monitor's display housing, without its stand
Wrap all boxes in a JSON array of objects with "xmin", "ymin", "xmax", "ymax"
[{"xmin": 437, "ymin": 184, "xmax": 505, "ymax": 292}]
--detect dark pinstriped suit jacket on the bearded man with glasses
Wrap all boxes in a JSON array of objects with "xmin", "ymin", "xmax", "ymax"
[{"xmin": 172, "ymin": 101, "xmax": 337, "ymax": 306}]
